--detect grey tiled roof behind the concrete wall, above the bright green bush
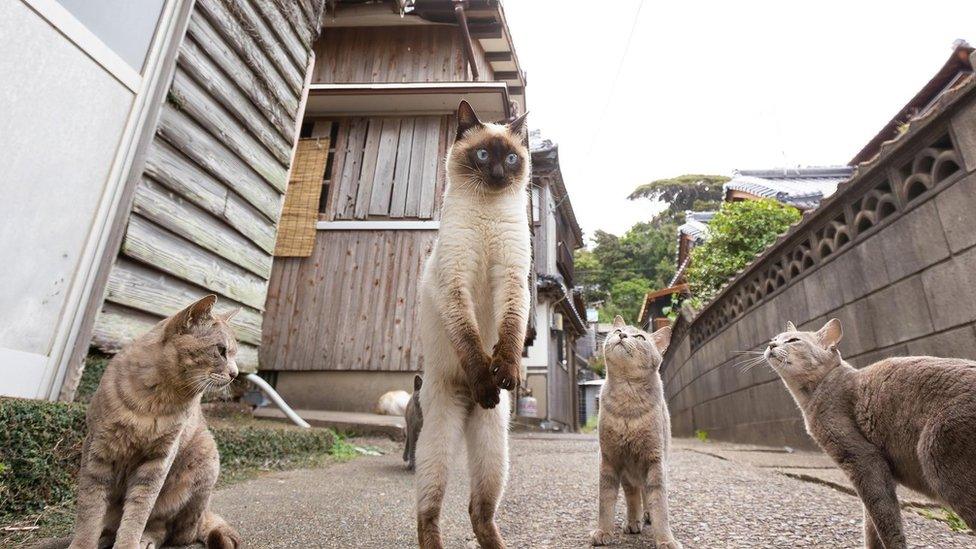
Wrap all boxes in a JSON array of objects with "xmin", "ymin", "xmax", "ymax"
[{"xmin": 722, "ymin": 166, "xmax": 854, "ymax": 210}]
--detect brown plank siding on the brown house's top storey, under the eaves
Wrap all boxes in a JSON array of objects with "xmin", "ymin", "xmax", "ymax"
[{"xmin": 312, "ymin": 25, "xmax": 492, "ymax": 84}]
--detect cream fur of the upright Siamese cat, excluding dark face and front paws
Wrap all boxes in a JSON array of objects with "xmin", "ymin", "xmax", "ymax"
[{"xmin": 416, "ymin": 111, "xmax": 531, "ymax": 549}]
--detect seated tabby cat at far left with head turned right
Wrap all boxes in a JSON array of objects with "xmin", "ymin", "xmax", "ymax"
[{"xmin": 71, "ymin": 295, "xmax": 241, "ymax": 549}]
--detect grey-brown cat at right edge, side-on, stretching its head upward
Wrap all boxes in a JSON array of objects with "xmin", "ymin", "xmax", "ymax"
[{"xmin": 764, "ymin": 319, "xmax": 976, "ymax": 549}]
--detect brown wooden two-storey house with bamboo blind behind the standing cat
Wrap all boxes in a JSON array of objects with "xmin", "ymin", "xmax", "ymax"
[{"xmin": 260, "ymin": 0, "xmax": 525, "ymax": 412}]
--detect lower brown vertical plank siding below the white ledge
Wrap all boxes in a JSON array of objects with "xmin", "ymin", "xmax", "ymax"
[{"xmin": 260, "ymin": 227, "xmax": 437, "ymax": 371}]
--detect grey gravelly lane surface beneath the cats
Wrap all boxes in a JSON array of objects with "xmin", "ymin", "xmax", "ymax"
[{"xmin": 214, "ymin": 435, "xmax": 976, "ymax": 549}]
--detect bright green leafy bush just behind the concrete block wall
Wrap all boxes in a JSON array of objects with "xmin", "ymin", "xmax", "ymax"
[{"xmin": 687, "ymin": 199, "xmax": 800, "ymax": 304}]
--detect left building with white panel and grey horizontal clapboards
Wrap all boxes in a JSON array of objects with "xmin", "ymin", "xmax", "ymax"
[{"xmin": 0, "ymin": 0, "xmax": 325, "ymax": 399}]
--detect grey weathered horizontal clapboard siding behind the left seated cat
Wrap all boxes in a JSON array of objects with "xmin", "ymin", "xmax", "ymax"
[{"xmin": 93, "ymin": 0, "xmax": 323, "ymax": 371}]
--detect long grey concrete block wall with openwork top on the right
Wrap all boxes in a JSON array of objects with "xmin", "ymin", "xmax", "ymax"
[{"xmin": 662, "ymin": 80, "xmax": 976, "ymax": 447}]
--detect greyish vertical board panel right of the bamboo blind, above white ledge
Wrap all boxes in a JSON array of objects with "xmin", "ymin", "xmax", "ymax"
[{"xmin": 324, "ymin": 116, "xmax": 454, "ymax": 221}]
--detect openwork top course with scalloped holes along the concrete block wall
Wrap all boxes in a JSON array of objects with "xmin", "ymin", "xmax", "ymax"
[{"xmin": 662, "ymin": 71, "xmax": 976, "ymax": 356}]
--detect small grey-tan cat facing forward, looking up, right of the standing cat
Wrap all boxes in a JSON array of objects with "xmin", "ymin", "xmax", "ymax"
[{"xmin": 590, "ymin": 316, "xmax": 681, "ymax": 549}]
